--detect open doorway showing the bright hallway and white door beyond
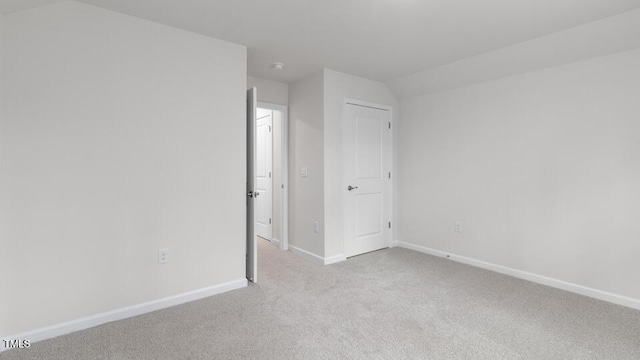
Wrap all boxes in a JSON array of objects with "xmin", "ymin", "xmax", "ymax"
[{"xmin": 255, "ymin": 102, "xmax": 288, "ymax": 250}]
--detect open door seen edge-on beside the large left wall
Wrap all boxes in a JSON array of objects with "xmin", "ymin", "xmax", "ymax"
[{"xmin": 247, "ymin": 87, "xmax": 258, "ymax": 283}]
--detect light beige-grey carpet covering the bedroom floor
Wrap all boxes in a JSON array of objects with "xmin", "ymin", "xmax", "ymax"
[{"xmin": 5, "ymin": 241, "xmax": 640, "ymax": 360}]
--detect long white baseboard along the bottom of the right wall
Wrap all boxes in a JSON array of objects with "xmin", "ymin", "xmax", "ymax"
[{"xmin": 398, "ymin": 241, "xmax": 640, "ymax": 310}]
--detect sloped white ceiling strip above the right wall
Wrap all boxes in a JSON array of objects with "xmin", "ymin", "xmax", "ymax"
[{"xmin": 386, "ymin": 9, "xmax": 640, "ymax": 99}]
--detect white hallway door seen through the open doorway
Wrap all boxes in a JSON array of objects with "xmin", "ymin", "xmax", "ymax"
[{"xmin": 255, "ymin": 109, "xmax": 273, "ymax": 241}]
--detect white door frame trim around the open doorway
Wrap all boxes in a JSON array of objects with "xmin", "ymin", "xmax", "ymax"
[{"xmin": 258, "ymin": 101, "xmax": 289, "ymax": 251}]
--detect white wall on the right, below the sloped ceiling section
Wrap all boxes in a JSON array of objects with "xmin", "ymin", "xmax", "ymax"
[{"xmin": 396, "ymin": 50, "xmax": 640, "ymax": 299}]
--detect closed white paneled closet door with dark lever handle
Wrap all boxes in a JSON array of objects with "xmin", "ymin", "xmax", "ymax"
[{"xmin": 343, "ymin": 102, "xmax": 391, "ymax": 257}]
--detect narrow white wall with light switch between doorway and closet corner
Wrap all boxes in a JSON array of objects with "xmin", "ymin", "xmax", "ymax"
[{"xmin": 289, "ymin": 71, "xmax": 324, "ymax": 257}]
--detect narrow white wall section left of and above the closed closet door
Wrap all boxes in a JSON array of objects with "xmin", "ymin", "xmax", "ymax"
[{"xmin": 324, "ymin": 69, "xmax": 399, "ymax": 258}]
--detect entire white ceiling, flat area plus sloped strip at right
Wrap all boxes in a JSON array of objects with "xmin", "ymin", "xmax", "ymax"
[{"xmin": 0, "ymin": 0, "xmax": 640, "ymax": 98}]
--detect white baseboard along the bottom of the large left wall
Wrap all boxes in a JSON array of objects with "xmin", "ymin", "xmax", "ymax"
[{"xmin": 0, "ymin": 279, "xmax": 247, "ymax": 352}]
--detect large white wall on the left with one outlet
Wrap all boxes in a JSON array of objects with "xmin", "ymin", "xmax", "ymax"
[{"xmin": 0, "ymin": 2, "xmax": 246, "ymax": 335}]
